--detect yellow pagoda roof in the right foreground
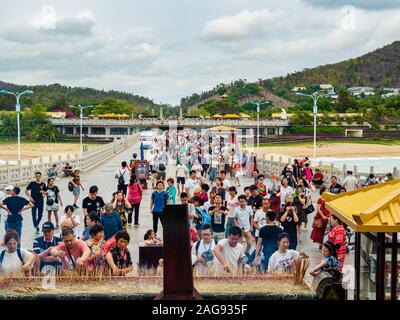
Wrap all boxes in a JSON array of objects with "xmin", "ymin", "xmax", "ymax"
[{"xmin": 322, "ymin": 179, "xmax": 400, "ymax": 232}]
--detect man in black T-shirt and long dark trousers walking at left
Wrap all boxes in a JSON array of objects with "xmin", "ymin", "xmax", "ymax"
[{"xmin": 25, "ymin": 171, "xmax": 46, "ymax": 234}]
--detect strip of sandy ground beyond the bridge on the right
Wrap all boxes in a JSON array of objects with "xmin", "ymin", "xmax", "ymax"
[{"xmin": 252, "ymin": 143, "xmax": 400, "ymax": 158}]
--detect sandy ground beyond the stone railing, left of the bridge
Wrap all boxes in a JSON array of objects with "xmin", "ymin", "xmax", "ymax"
[{"xmin": 0, "ymin": 143, "xmax": 99, "ymax": 161}]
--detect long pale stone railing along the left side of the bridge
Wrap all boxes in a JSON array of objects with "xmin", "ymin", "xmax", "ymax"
[{"xmin": 0, "ymin": 134, "xmax": 140, "ymax": 189}]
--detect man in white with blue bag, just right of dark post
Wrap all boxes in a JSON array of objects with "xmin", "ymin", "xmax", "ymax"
[{"xmin": 192, "ymin": 224, "xmax": 216, "ymax": 275}]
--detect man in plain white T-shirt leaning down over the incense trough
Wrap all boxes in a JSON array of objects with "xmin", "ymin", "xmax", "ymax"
[{"xmin": 214, "ymin": 227, "xmax": 244, "ymax": 273}]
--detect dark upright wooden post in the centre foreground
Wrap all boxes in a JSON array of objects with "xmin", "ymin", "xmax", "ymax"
[{"xmin": 155, "ymin": 205, "xmax": 202, "ymax": 300}]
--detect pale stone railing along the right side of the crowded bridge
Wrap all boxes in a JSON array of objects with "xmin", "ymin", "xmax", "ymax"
[{"xmin": 257, "ymin": 156, "xmax": 400, "ymax": 185}]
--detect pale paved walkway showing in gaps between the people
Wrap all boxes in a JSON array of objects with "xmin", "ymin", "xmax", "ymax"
[{"xmin": 0, "ymin": 144, "xmax": 353, "ymax": 278}]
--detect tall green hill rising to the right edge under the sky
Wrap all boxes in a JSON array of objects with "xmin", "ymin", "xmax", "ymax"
[{"xmin": 181, "ymin": 41, "xmax": 400, "ymax": 110}]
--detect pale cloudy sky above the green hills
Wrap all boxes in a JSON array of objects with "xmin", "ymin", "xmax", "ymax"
[{"xmin": 0, "ymin": 0, "xmax": 400, "ymax": 105}]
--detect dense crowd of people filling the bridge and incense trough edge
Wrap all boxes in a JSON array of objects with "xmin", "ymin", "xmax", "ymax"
[{"xmin": 0, "ymin": 130, "xmax": 394, "ymax": 275}]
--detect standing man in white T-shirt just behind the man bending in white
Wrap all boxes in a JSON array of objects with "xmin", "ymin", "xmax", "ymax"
[{"xmin": 233, "ymin": 195, "xmax": 253, "ymax": 254}]
